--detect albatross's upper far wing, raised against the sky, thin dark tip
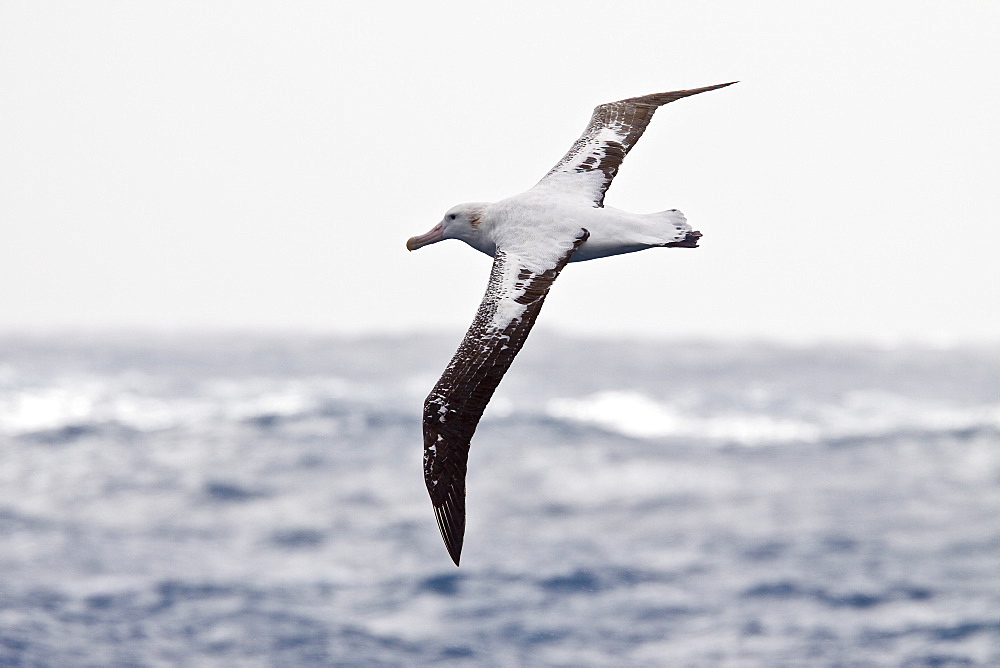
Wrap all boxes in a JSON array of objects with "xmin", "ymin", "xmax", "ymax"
[{"xmin": 535, "ymin": 81, "xmax": 736, "ymax": 207}]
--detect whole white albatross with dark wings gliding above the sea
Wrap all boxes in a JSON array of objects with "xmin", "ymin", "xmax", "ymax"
[{"xmin": 406, "ymin": 81, "xmax": 736, "ymax": 566}]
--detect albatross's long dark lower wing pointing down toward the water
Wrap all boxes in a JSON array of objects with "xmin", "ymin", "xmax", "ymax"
[{"xmin": 424, "ymin": 230, "xmax": 590, "ymax": 566}]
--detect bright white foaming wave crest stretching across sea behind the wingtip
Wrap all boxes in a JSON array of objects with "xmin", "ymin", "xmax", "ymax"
[{"xmin": 7, "ymin": 376, "xmax": 1000, "ymax": 446}]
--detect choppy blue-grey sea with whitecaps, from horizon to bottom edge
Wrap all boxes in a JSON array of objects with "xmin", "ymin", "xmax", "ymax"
[{"xmin": 0, "ymin": 332, "xmax": 1000, "ymax": 666}]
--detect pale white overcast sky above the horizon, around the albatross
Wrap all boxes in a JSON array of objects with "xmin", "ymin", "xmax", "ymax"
[{"xmin": 0, "ymin": 0, "xmax": 1000, "ymax": 344}]
